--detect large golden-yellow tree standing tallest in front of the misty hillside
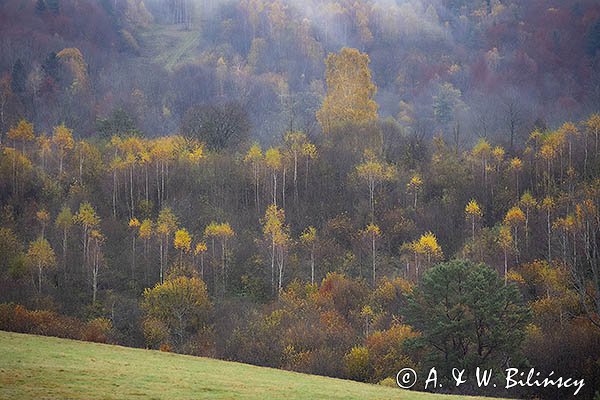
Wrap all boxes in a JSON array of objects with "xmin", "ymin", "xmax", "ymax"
[{"xmin": 317, "ymin": 47, "xmax": 377, "ymax": 133}]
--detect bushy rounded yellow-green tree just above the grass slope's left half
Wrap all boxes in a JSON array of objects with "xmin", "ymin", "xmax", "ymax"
[{"xmin": 142, "ymin": 276, "xmax": 212, "ymax": 349}]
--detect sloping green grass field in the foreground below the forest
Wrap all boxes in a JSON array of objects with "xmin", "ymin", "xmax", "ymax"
[{"xmin": 0, "ymin": 331, "xmax": 496, "ymax": 400}]
